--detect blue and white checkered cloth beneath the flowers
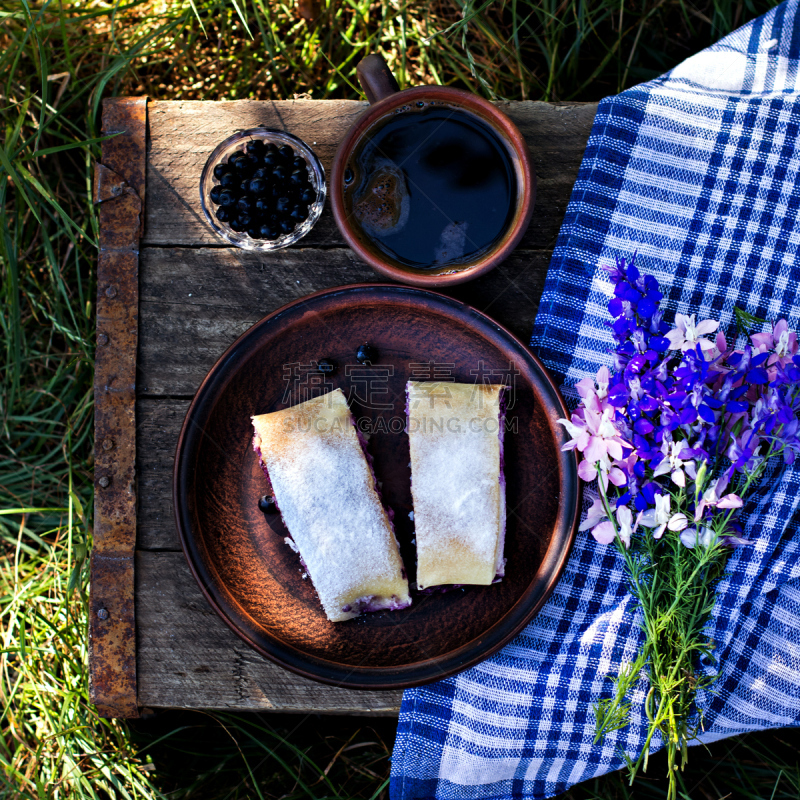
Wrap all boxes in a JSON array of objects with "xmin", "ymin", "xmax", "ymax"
[{"xmin": 391, "ymin": 0, "xmax": 800, "ymax": 800}]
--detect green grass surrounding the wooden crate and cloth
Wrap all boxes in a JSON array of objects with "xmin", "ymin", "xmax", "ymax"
[{"xmin": 0, "ymin": 0, "xmax": 800, "ymax": 800}]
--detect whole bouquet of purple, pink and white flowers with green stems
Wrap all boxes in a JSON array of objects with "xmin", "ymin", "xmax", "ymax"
[{"xmin": 561, "ymin": 256, "xmax": 800, "ymax": 798}]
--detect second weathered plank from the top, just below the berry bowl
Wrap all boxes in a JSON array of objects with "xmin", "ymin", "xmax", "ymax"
[{"xmin": 137, "ymin": 247, "xmax": 551, "ymax": 397}]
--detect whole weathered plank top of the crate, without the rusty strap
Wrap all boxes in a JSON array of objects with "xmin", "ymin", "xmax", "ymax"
[{"xmin": 136, "ymin": 101, "xmax": 596, "ymax": 714}]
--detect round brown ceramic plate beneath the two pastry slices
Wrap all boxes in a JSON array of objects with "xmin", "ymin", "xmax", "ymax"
[{"xmin": 174, "ymin": 284, "xmax": 580, "ymax": 689}]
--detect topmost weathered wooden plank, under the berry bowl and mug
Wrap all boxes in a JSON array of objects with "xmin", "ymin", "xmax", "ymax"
[{"xmin": 144, "ymin": 100, "xmax": 597, "ymax": 250}]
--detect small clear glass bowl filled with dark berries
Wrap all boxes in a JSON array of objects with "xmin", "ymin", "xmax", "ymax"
[{"xmin": 200, "ymin": 128, "xmax": 325, "ymax": 250}]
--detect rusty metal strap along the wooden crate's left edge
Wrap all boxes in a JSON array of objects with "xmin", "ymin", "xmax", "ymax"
[{"xmin": 89, "ymin": 97, "xmax": 147, "ymax": 718}]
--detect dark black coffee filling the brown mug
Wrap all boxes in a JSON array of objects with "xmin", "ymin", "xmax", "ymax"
[{"xmin": 344, "ymin": 103, "xmax": 517, "ymax": 269}]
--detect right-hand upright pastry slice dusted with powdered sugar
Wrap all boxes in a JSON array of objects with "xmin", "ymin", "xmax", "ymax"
[{"xmin": 406, "ymin": 381, "xmax": 506, "ymax": 589}]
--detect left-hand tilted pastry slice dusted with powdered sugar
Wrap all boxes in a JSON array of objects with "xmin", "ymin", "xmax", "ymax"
[{"xmin": 253, "ymin": 389, "xmax": 411, "ymax": 622}]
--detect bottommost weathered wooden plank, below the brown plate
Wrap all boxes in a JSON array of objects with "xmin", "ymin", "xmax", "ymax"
[{"xmin": 136, "ymin": 552, "xmax": 402, "ymax": 716}]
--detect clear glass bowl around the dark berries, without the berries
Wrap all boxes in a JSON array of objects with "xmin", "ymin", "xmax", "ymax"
[{"xmin": 200, "ymin": 128, "xmax": 326, "ymax": 251}]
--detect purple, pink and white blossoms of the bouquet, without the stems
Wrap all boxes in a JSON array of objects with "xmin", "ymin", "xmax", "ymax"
[{"xmin": 559, "ymin": 254, "xmax": 800, "ymax": 560}]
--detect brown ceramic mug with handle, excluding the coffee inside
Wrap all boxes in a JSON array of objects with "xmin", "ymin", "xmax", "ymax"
[{"xmin": 330, "ymin": 55, "xmax": 536, "ymax": 287}]
